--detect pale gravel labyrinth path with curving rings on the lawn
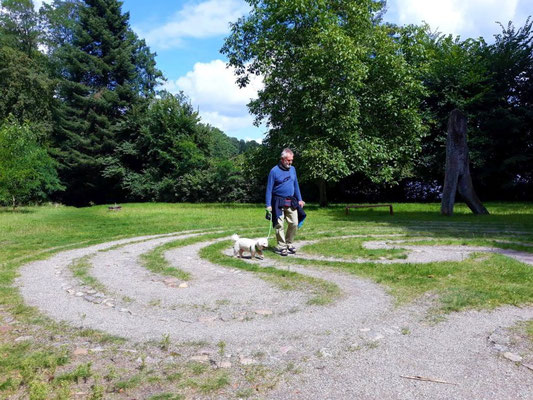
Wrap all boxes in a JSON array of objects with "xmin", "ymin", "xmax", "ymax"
[{"xmin": 17, "ymin": 231, "xmax": 533, "ymax": 399}]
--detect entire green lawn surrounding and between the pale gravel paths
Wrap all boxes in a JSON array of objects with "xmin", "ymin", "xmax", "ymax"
[{"xmin": 0, "ymin": 203, "xmax": 533, "ymax": 399}]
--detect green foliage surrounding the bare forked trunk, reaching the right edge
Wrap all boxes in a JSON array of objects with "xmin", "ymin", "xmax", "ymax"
[{"xmin": 400, "ymin": 20, "xmax": 533, "ymax": 198}]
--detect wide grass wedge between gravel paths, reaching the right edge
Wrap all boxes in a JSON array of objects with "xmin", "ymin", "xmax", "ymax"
[{"xmin": 289, "ymin": 254, "xmax": 533, "ymax": 312}]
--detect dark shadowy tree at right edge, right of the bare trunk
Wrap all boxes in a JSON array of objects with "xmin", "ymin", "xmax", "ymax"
[{"xmin": 469, "ymin": 19, "xmax": 533, "ymax": 200}]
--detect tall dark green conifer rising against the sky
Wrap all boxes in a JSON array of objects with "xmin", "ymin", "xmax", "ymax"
[{"xmin": 51, "ymin": 0, "xmax": 162, "ymax": 204}]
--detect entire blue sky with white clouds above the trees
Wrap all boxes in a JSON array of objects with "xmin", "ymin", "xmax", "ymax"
[{"xmin": 34, "ymin": 0, "xmax": 533, "ymax": 141}]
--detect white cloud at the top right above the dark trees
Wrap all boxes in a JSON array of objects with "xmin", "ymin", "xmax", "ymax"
[{"xmin": 389, "ymin": 0, "xmax": 520, "ymax": 38}]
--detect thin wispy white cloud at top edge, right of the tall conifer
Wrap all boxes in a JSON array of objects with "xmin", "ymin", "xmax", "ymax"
[{"xmin": 141, "ymin": 0, "xmax": 249, "ymax": 49}]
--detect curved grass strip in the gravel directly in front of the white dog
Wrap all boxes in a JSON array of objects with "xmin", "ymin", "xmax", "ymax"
[{"xmin": 200, "ymin": 240, "xmax": 341, "ymax": 305}]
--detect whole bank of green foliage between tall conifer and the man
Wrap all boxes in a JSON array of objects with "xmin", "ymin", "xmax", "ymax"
[{"xmin": 104, "ymin": 92, "xmax": 256, "ymax": 202}]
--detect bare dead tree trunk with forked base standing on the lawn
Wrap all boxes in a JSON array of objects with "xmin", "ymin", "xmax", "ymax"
[{"xmin": 440, "ymin": 110, "xmax": 489, "ymax": 215}]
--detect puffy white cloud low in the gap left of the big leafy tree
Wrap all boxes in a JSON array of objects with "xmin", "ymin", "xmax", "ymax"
[{"xmin": 162, "ymin": 60, "xmax": 263, "ymax": 136}]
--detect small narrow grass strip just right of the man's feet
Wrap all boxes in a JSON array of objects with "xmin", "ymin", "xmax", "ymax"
[{"xmin": 302, "ymin": 238, "xmax": 407, "ymax": 260}]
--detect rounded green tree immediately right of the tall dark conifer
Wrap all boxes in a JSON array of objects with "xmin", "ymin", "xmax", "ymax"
[{"xmin": 104, "ymin": 92, "xmax": 212, "ymax": 201}]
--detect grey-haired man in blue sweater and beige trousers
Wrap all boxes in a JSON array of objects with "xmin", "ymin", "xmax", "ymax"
[{"xmin": 265, "ymin": 149, "xmax": 305, "ymax": 256}]
